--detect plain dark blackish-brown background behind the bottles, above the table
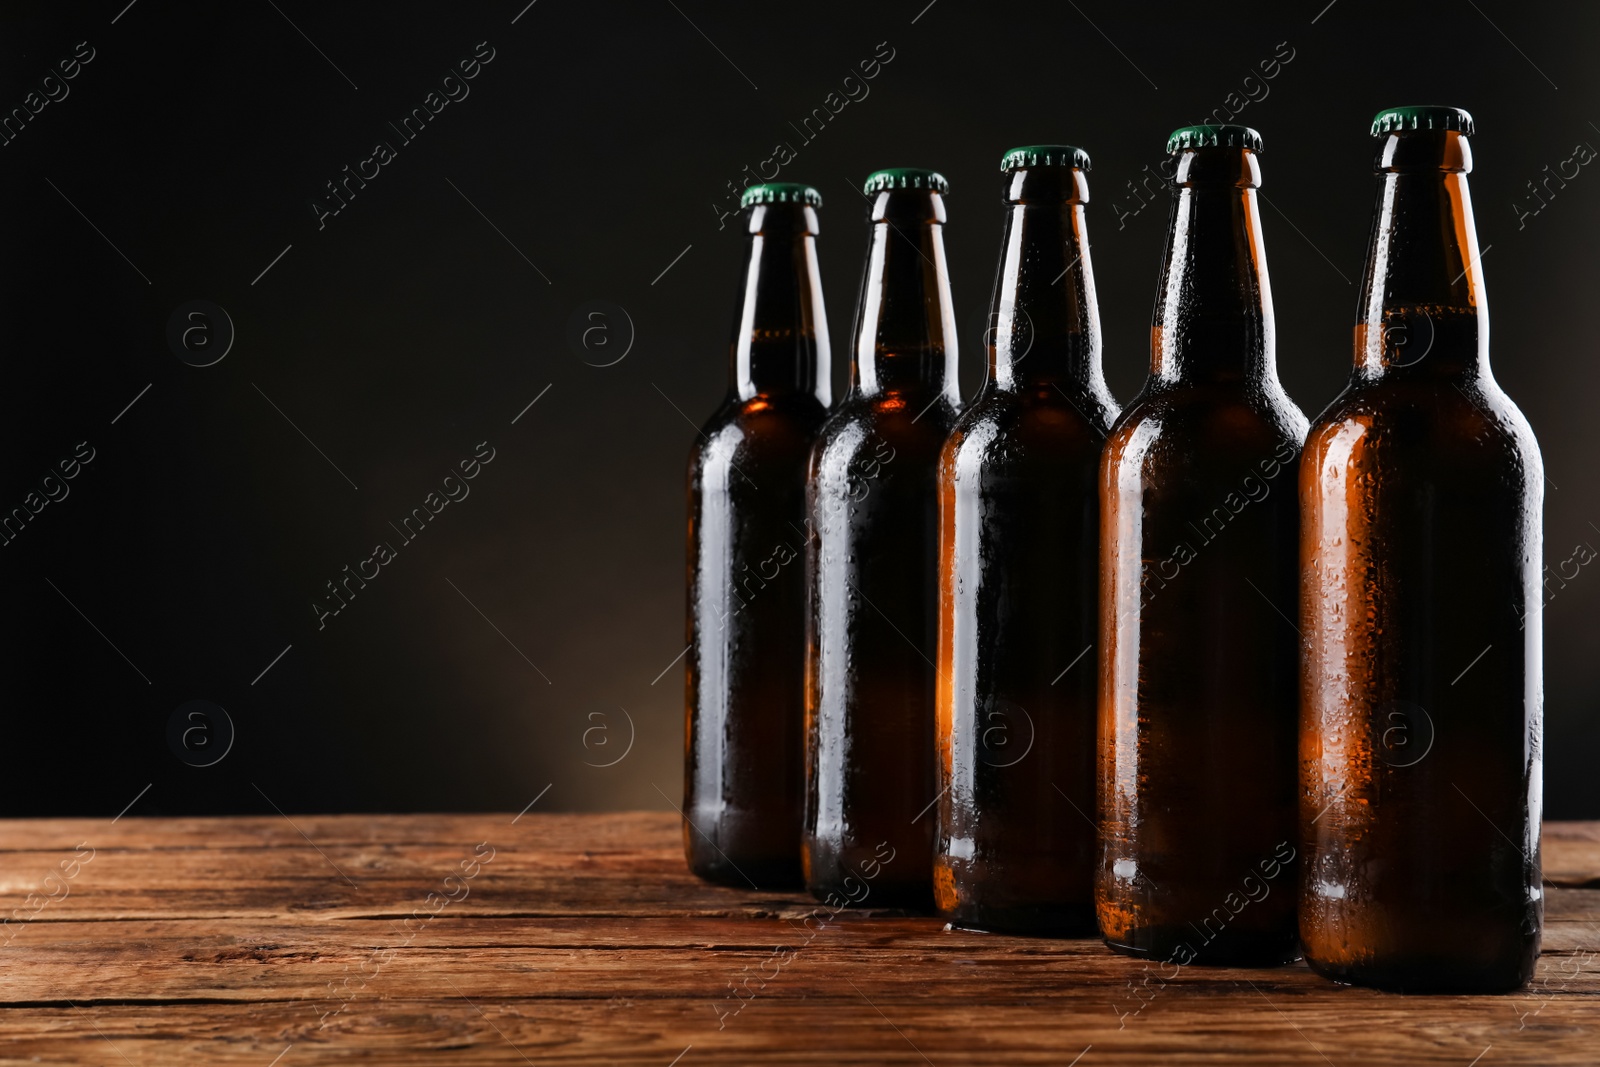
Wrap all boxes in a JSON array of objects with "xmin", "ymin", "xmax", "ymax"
[{"xmin": 0, "ymin": 0, "xmax": 1600, "ymax": 817}]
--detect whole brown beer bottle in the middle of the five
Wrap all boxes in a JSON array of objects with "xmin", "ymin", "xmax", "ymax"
[{"xmin": 933, "ymin": 144, "xmax": 1117, "ymax": 936}]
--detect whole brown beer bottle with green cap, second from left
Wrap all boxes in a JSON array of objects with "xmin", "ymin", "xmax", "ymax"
[{"xmin": 805, "ymin": 168, "xmax": 960, "ymax": 907}]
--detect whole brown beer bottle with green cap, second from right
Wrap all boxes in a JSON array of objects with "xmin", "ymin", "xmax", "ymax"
[{"xmin": 1096, "ymin": 125, "xmax": 1306, "ymax": 966}]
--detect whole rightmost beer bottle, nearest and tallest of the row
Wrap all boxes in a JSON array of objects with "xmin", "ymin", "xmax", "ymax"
[{"xmin": 1299, "ymin": 107, "xmax": 1544, "ymax": 992}]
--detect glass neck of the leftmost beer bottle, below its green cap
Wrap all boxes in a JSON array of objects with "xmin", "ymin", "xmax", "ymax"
[{"xmin": 728, "ymin": 205, "xmax": 830, "ymax": 406}]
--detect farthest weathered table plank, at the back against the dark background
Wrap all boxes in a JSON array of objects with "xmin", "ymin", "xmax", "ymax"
[{"xmin": 0, "ymin": 813, "xmax": 1600, "ymax": 918}]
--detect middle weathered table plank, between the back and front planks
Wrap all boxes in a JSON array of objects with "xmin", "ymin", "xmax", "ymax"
[{"xmin": 0, "ymin": 917, "xmax": 1600, "ymax": 1006}]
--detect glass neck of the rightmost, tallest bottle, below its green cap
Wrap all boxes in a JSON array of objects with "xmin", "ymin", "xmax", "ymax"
[{"xmin": 1355, "ymin": 130, "xmax": 1490, "ymax": 379}]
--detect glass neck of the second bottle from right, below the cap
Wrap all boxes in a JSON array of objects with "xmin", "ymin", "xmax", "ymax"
[{"xmin": 1150, "ymin": 147, "xmax": 1277, "ymax": 384}]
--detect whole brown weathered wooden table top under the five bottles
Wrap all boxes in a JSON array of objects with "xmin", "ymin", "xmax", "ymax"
[{"xmin": 0, "ymin": 813, "xmax": 1600, "ymax": 1067}]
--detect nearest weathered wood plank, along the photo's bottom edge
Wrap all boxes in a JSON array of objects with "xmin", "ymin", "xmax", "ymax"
[{"xmin": 0, "ymin": 1004, "xmax": 1597, "ymax": 1067}]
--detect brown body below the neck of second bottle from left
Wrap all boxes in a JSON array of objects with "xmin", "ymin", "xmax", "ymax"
[{"xmin": 806, "ymin": 397, "xmax": 955, "ymax": 907}]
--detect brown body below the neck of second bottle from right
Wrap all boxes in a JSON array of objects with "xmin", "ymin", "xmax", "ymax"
[{"xmin": 1098, "ymin": 396, "xmax": 1302, "ymax": 966}]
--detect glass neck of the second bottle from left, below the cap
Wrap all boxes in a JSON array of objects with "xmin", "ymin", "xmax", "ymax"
[{"xmin": 851, "ymin": 190, "xmax": 960, "ymax": 403}]
